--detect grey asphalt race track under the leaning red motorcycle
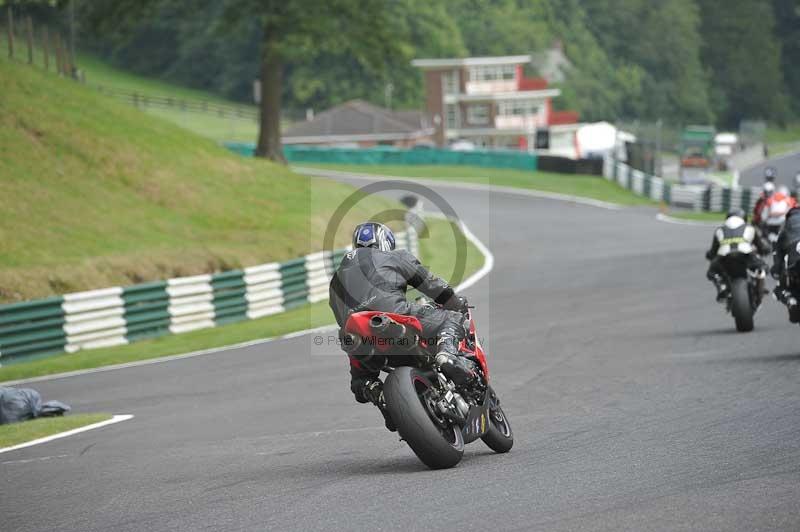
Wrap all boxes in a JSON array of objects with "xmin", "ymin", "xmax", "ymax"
[{"xmin": 0, "ymin": 180, "xmax": 800, "ymax": 532}]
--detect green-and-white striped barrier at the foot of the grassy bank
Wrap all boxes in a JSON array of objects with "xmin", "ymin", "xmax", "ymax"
[{"xmin": 0, "ymin": 226, "xmax": 418, "ymax": 365}]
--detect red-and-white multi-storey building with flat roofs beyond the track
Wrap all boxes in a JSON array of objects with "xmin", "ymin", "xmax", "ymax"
[{"xmin": 412, "ymin": 55, "xmax": 578, "ymax": 150}]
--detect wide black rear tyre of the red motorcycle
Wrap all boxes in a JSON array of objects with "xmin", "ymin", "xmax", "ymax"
[{"xmin": 383, "ymin": 366, "xmax": 464, "ymax": 469}]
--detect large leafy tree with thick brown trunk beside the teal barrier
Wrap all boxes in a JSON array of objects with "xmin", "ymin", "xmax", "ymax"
[{"xmin": 79, "ymin": 0, "xmax": 408, "ymax": 162}]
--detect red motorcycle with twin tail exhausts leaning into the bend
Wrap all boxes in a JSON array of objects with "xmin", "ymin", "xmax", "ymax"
[{"xmin": 342, "ymin": 304, "xmax": 514, "ymax": 469}]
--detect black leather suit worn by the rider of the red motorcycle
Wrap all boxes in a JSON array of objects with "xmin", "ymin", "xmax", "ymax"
[{"xmin": 329, "ymin": 248, "xmax": 466, "ymax": 394}]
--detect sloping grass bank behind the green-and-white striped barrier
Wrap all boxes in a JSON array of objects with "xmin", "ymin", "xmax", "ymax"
[{"xmin": 0, "ymin": 58, "xmax": 396, "ymax": 303}]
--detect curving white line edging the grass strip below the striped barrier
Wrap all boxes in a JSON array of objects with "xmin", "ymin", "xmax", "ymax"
[{"xmin": 0, "ymin": 220, "xmax": 494, "ymax": 386}]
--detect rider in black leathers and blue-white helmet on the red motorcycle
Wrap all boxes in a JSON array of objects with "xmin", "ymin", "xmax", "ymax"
[{"xmin": 330, "ymin": 222, "xmax": 474, "ymax": 424}]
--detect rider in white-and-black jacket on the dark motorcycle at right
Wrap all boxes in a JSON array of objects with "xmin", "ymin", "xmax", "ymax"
[{"xmin": 706, "ymin": 209, "xmax": 771, "ymax": 301}]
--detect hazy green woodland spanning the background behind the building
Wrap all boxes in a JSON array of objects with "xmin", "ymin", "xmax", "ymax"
[{"xmin": 6, "ymin": 0, "xmax": 800, "ymax": 161}]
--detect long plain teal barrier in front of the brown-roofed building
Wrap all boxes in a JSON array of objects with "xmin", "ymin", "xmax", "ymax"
[{"xmin": 225, "ymin": 142, "xmax": 537, "ymax": 171}]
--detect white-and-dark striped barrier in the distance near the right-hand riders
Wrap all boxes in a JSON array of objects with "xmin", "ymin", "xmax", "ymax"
[{"xmin": 603, "ymin": 157, "xmax": 760, "ymax": 212}]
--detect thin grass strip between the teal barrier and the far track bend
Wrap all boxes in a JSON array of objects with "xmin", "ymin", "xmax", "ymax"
[{"xmin": 298, "ymin": 162, "xmax": 655, "ymax": 205}]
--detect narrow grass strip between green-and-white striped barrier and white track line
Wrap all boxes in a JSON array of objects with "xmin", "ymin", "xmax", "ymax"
[{"xmin": 0, "ymin": 220, "xmax": 483, "ymax": 382}]
